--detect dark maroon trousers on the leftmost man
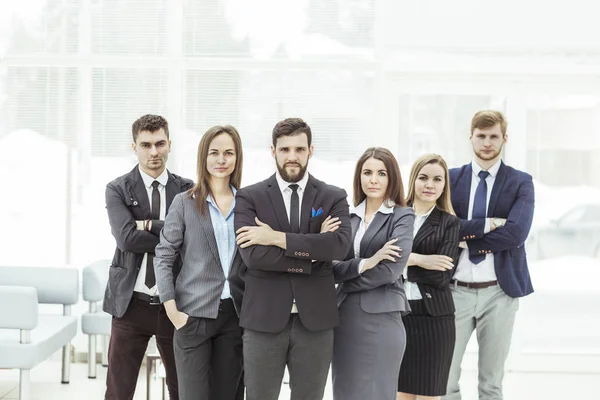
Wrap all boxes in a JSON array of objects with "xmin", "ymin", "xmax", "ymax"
[{"xmin": 105, "ymin": 298, "xmax": 179, "ymax": 400}]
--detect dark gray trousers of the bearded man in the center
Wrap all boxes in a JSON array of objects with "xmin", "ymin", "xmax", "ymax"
[{"xmin": 243, "ymin": 314, "xmax": 333, "ymax": 400}]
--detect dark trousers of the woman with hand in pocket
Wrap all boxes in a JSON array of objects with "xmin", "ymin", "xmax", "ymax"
[{"xmin": 173, "ymin": 299, "xmax": 244, "ymax": 400}]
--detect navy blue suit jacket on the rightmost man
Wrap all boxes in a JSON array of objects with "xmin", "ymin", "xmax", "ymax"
[{"xmin": 450, "ymin": 162, "xmax": 535, "ymax": 297}]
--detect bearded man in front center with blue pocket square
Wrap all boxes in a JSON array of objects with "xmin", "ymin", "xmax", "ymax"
[{"xmin": 235, "ymin": 118, "xmax": 351, "ymax": 400}]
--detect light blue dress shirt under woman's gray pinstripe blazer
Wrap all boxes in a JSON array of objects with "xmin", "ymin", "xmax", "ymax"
[{"xmin": 206, "ymin": 186, "xmax": 236, "ymax": 299}]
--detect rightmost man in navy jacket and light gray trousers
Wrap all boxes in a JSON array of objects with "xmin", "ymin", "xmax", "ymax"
[{"xmin": 443, "ymin": 110, "xmax": 534, "ymax": 400}]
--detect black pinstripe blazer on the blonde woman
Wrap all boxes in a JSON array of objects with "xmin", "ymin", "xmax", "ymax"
[{"xmin": 407, "ymin": 207, "xmax": 460, "ymax": 316}]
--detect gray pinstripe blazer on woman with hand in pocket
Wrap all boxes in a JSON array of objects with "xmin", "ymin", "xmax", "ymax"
[{"xmin": 154, "ymin": 193, "xmax": 246, "ymax": 319}]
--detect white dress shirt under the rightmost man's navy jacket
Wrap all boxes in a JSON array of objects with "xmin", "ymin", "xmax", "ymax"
[{"xmin": 454, "ymin": 160, "xmax": 501, "ymax": 282}]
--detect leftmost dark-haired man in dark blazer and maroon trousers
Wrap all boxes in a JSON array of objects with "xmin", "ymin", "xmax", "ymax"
[{"xmin": 103, "ymin": 115, "xmax": 193, "ymax": 400}]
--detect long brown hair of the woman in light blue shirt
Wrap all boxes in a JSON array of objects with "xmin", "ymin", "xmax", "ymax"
[{"xmin": 188, "ymin": 125, "xmax": 243, "ymax": 215}]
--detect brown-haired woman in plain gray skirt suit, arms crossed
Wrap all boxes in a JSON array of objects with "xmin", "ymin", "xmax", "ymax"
[{"xmin": 322, "ymin": 147, "xmax": 414, "ymax": 400}]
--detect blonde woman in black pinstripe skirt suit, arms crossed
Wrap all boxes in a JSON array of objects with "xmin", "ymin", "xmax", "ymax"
[{"xmin": 397, "ymin": 154, "xmax": 459, "ymax": 400}]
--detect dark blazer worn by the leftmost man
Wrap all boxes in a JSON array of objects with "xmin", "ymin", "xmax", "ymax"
[{"xmin": 102, "ymin": 165, "xmax": 193, "ymax": 318}]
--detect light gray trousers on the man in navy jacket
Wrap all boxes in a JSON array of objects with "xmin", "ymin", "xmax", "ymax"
[{"xmin": 443, "ymin": 284, "xmax": 519, "ymax": 400}]
